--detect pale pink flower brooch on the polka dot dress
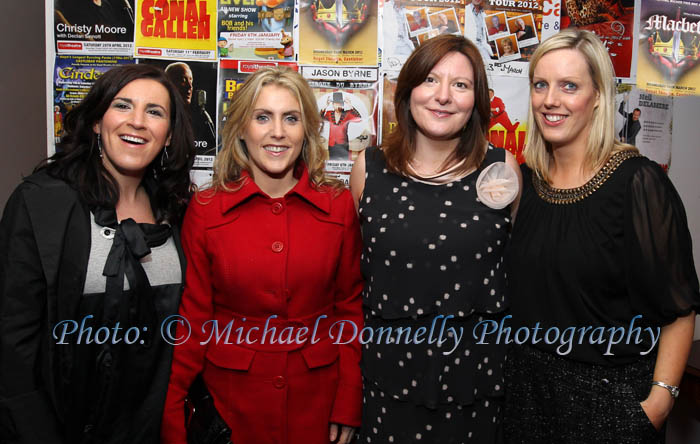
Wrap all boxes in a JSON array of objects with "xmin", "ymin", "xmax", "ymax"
[{"xmin": 476, "ymin": 162, "xmax": 520, "ymax": 210}]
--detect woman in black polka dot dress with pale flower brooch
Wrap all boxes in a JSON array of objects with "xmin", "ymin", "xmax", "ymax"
[{"xmin": 350, "ymin": 35, "xmax": 520, "ymax": 444}]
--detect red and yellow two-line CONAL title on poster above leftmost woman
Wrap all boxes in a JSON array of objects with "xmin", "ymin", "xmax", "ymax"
[{"xmin": 141, "ymin": 0, "xmax": 211, "ymax": 39}]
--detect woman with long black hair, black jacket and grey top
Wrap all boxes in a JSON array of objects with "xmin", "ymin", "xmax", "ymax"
[{"xmin": 0, "ymin": 64, "xmax": 194, "ymax": 444}]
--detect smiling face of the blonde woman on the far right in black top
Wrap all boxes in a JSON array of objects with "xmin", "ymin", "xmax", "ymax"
[{"xmin": 530, "ymin": 49, "xmax": 599, "ymax": 150}]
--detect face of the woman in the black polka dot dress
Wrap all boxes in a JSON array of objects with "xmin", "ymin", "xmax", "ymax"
[{"xmin": 410, "ymin": 52, "xmax": 474, "ymax": 143}]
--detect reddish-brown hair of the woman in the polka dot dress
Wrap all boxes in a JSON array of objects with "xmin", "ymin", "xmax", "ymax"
[{"xmin": 382, "ymin": 34, "xmax": 491, "ymax": 175}]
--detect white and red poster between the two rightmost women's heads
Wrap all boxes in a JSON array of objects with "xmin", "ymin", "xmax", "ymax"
[{"xmin": 489, "ymin": 75, "xmax": 529, "ymax": 163}]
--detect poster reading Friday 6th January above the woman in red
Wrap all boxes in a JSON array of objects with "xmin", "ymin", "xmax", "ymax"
[{"xmin": 216, "ymin": 0, "xmax": 295, "ymax": 61}]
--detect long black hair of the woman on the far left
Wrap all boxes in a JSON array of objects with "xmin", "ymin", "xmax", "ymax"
[{"xmin": 37, "ymin": 64, "xmax": 195, "ymax": 223}]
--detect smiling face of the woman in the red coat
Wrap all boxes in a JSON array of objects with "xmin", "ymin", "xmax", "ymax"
[{"xmin": 242, "ymin": 85, "xmax": 304, "ymax": 189}]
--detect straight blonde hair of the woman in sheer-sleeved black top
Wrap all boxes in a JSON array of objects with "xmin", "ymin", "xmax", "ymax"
[{"xmin": 524, "ymin": 28, "xmax": 637, "ymax": 182}]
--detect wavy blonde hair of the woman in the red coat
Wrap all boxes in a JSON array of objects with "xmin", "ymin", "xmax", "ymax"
[{"xmin": 212, "ymin": 67, "xmax": 343, "ymax": 191}]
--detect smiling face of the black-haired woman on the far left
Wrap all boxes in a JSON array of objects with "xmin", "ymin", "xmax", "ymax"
[{"xmin": 93, "ymin": 79, "xmax": 171, "ymax": 180}]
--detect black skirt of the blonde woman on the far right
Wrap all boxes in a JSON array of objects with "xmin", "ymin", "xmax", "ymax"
[{"xmin": 503, "ymin": 345, "xmax": 664, "ymax": 444}]
